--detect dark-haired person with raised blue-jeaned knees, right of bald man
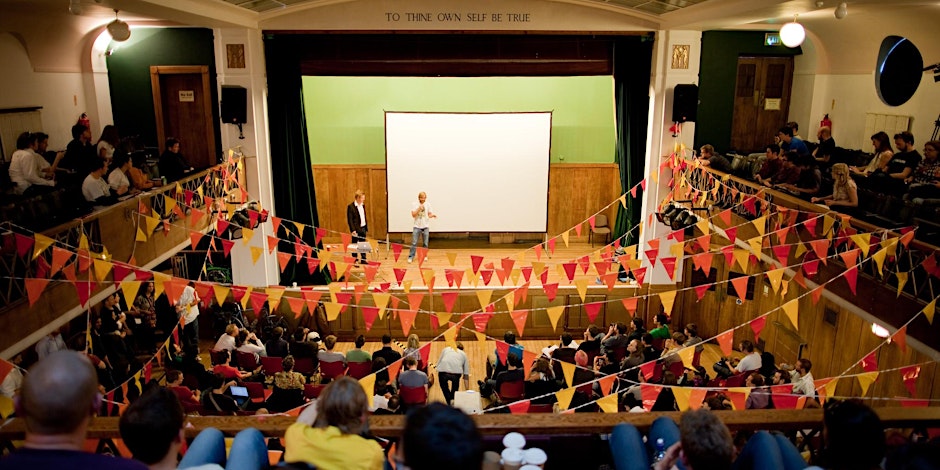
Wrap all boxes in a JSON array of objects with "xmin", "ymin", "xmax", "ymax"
[{"xmin": 120, "ymin": 388, "xmax": 268, "ymax": 470}]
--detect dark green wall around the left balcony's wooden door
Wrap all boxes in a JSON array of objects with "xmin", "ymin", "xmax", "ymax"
[{"xmin": 105, "ymin": 28, "xmax": 222, "ymax": 149}]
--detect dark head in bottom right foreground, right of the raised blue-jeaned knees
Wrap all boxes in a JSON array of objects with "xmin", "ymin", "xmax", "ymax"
[{"xmin": 809, "ymin": 400, "xmax": 887, "ymax": 470}]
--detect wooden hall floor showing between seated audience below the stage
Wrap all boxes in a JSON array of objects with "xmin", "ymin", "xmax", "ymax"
[{"xmin": 201, "ymin": 338, "xmax": 736, "ymax": 408}]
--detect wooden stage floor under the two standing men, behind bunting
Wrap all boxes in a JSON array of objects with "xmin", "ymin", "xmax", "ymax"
[{"xmin": 334, "ymin": 238, "xmax": 622, "ymax": 289}]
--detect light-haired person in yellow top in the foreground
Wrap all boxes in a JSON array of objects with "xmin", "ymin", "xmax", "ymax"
[{"xmin": 284, "ymin": 376, "xmax": 384, "ymax": 470}]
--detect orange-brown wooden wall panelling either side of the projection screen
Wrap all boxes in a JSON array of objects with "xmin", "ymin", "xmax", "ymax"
[{"xmin": 312, "ymin": 163, "xmax": 620, "ymax": 243}]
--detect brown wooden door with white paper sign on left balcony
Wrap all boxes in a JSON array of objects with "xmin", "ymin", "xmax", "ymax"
[{"xmin": 150, "ymin": 66, "xmax": 218, "ymax": 168}]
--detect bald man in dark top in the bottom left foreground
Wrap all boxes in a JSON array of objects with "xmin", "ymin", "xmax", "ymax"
[{"xmin": 0, "ymin": 351, "xmax": 147, "ymax": 470}]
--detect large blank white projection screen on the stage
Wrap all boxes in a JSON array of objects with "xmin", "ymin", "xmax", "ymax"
[{"xmin": 385, "ymin": 112, "xmax": 552, "ymax": 233}]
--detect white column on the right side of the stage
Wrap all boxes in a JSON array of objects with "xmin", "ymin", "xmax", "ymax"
[{"xmin": 638, "ymin": 31, "xmax": 702, "ymax": 284}]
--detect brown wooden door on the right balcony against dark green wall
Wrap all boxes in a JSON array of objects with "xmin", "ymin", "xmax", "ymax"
[{"xmin": 731, "ymin": 57, "xmax": 793, "ymax": 154}]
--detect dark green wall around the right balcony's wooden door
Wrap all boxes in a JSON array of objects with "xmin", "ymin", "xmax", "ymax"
[{"xmin": 694, "ymin": 31, "xmax": 803, "ymax": 153}]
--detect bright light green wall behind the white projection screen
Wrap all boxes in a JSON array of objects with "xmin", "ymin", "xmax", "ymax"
[{"xmin": 303, "ymin": 76, "xmax": 616, "ymax": 164}]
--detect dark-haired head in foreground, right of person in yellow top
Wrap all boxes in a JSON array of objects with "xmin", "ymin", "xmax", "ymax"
[{"xmin": 398, "ymin": 403, "xmax": 483, "ymax": 470}]
